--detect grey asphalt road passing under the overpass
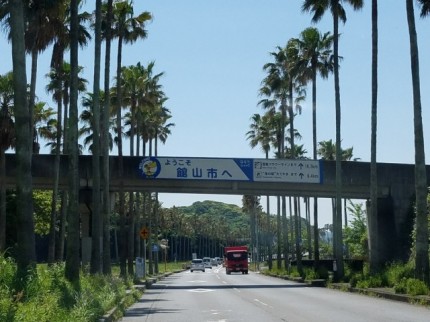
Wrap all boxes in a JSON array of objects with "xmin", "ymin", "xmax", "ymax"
[{"xmin": 121, "ymin": 267, "xmax": 430, "ymax": 322}]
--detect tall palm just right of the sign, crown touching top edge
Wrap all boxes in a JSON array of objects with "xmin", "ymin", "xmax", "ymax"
[{"xmin": 302, "ymin": 0, "xmax": 363, "ymax": 280}]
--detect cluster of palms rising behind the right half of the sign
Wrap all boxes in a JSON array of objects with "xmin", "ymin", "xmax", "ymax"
[{"xmin": 255, "ymin": 28, "xmax": 333, "ymax": 272}]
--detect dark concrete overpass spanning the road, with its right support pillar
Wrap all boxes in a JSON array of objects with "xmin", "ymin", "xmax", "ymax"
[{"xmin": 5, "ymin": 154, "xmax": 430, "ymax": 261}]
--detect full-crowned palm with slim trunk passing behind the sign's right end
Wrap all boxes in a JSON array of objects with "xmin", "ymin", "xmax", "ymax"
[{"xmin": 298, "ymin": 27, "xmax": 333, "ymax": 267}]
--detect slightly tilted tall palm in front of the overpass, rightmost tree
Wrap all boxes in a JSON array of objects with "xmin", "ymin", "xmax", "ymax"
[{"xmin": 406, "ymin": 0, "xmax": 430, "ymax": 284}]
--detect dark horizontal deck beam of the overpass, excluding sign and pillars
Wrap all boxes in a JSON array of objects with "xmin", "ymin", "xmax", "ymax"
[{"xmin": 2, "ymin": 154, "xmax": 404, "ymax": 199}]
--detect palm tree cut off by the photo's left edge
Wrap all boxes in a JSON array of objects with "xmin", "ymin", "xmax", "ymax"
[{"xmin": 0, "ymin": 72, "xmax": 15, "ymax": 253}]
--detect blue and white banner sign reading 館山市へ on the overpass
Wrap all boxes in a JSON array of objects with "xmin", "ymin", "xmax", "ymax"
[{"xmin": 139, "ymin": 157, "xmax": 322, "ymax": 183}]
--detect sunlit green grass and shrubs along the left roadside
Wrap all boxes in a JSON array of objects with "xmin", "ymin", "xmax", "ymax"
[{"xmin": 0, "ymin": 256, "xmax": 136, "ymax": 322}]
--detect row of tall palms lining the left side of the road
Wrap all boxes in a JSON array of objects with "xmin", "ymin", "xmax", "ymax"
[{"xmin": 0, "ymin": 0, "xmax": 173, "ymax": 281}]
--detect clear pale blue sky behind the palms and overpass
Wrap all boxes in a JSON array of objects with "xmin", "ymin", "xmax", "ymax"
[{"xmin": 0, "ymin": 0, "xmax": 430, "ymax": 226}]
